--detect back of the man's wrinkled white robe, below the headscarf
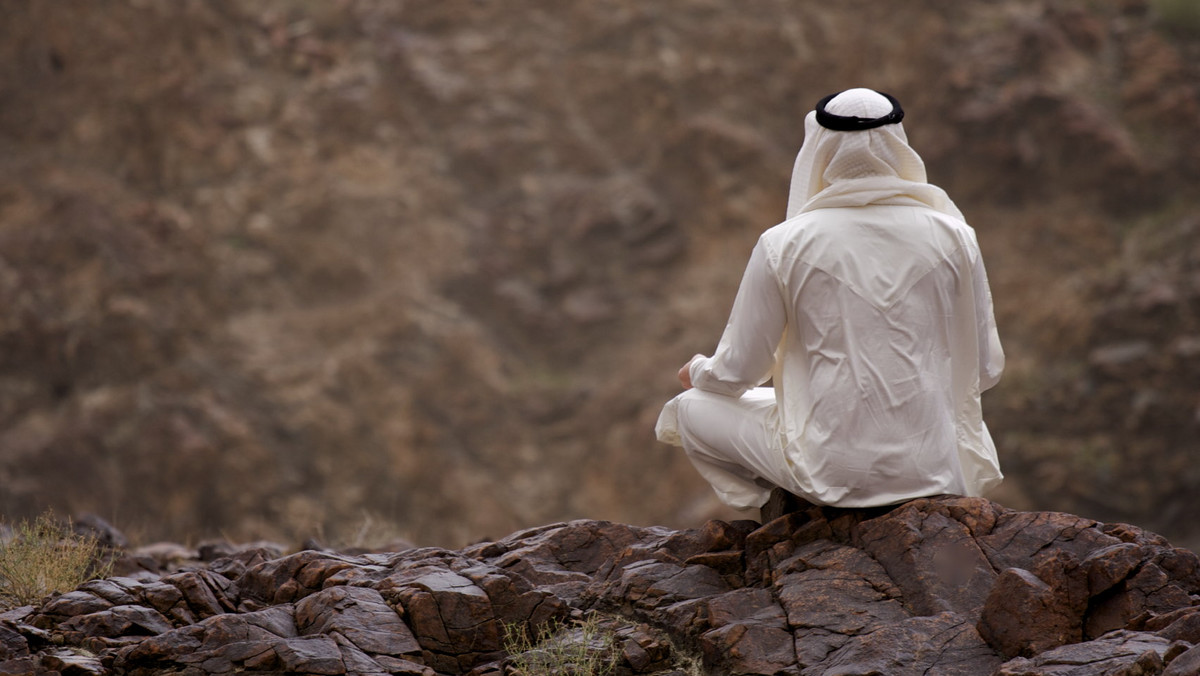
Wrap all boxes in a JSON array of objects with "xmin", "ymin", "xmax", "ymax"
[{"xmin": 762, "ymin": 205, "xmax": 988, "ymax": 505}]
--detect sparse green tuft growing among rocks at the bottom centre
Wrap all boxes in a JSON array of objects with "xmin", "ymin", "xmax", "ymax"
[{"xmin": 504, "ymin": 615, "xmax": 616, "ymax": 676}]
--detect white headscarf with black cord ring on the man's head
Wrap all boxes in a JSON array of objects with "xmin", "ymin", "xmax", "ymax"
[{"xmin": 787, "ymin": 88, "xmax": 962, "ymax": 220}]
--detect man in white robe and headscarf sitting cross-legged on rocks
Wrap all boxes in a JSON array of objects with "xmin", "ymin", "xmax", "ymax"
[{"xmin": 656, "ymin": 89, "xmax": 1004, "ymax": 509}]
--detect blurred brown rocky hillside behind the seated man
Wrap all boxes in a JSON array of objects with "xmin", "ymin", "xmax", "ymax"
[{"xmin": 0, "ymin": 0, "xmax": 1200, "ymax": 548}]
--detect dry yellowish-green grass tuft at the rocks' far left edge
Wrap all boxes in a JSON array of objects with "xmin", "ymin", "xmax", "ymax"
[{"xmin": 0, "ymin": 513, "xmax": 112, "ymax": 609}]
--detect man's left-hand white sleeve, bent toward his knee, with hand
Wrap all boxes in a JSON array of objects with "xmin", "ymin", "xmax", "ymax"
[{"xmin": 689, "ymin": 239, "xmax": 787, "ymax": 397}]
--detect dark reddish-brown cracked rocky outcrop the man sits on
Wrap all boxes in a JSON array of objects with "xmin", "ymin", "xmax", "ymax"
[{"xmin": 0, "ymin": 497, "xmax": 1200, "ymax": 676}]
